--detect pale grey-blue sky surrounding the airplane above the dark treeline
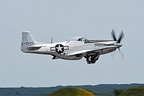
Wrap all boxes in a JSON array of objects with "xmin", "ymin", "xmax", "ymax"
[{"xmin": 0, "ymin": 0, "xmax": 144, "ymax": 87}]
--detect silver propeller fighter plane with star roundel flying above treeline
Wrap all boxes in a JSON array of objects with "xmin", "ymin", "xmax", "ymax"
[{"xmin": 21, "ymin": 30, "xmax": 124, "ymax": 64}]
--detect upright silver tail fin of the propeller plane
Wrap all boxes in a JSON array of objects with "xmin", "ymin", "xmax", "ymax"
[{"xmin": 21, "ymin": 32, "xmax": 36, "ymax": 52}]
